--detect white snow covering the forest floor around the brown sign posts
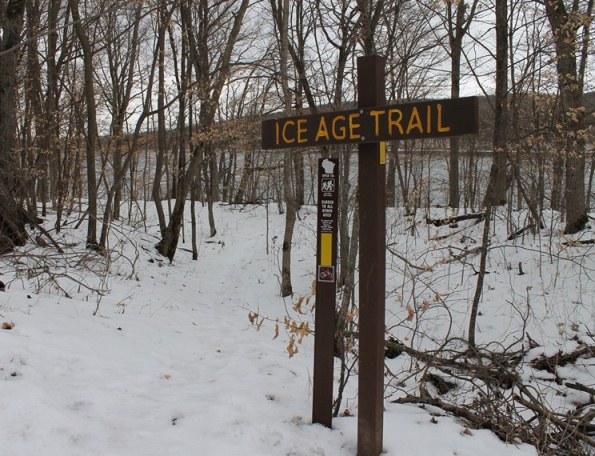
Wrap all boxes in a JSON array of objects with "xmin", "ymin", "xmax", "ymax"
[{"xmin": 0, "ymin": 206, "xmax": 593, "ymax": 456}]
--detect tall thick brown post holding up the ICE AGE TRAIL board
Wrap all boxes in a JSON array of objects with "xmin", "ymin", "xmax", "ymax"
[{"xmin": 357, "ymin": 55, "xmax": 386, "ymax": 456}]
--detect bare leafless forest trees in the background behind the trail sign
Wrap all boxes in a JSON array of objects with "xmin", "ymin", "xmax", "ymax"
[{"xmin": 0, "ymin": 0, "xmax": 595, "ymax": 454}]
